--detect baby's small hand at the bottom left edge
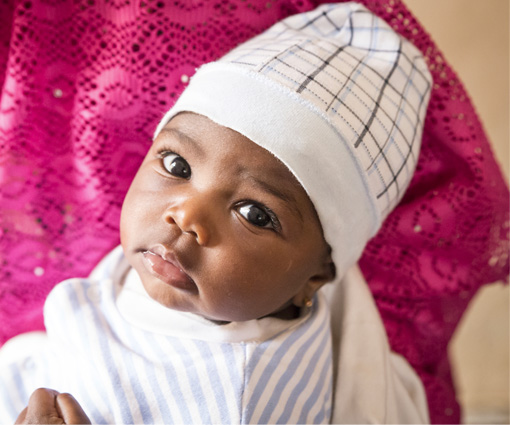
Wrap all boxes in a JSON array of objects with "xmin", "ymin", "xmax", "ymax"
[{"xmin": 16, "ymin": 388, "xmax": 90, "ymax": 424}]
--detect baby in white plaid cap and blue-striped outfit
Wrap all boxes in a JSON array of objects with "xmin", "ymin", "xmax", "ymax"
[{"xmin": 0, "ymin": 3, "xmax": 431, "ymax": 423}]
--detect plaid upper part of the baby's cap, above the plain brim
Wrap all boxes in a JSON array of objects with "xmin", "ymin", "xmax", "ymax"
[{"xmin": 222, "ymin": 5, "xmax": 431, "ymax": 217}]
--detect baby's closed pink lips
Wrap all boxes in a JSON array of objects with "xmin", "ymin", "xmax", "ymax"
[{"xmin": 142, "ymin": 245, "xmax": 198, "ymax": 292}]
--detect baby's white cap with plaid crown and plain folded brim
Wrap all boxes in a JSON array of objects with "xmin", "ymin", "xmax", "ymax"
[{"xmin": 155, "ymin": 3, "xmax": 432, "ymax": 279}]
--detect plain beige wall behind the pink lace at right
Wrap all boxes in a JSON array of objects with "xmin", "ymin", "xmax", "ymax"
[{"xmin": 404, "ymin": 0, "xmax": 510, "ymax": 423}]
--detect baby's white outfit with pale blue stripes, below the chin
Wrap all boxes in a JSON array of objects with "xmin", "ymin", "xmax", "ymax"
[{"xmin": 0, "ymin": 249, "xmax": 332, "ymax": 424}]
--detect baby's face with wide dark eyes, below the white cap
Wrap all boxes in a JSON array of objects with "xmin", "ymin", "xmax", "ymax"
[{"xmin": 121, "ymin": 113, "xmax": 333, "ymax": 321}]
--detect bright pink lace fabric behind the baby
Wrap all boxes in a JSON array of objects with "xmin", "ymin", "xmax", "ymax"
[{"xmin": 0, "ymin": 0, "xmax": 509, "ymax": 423}]
